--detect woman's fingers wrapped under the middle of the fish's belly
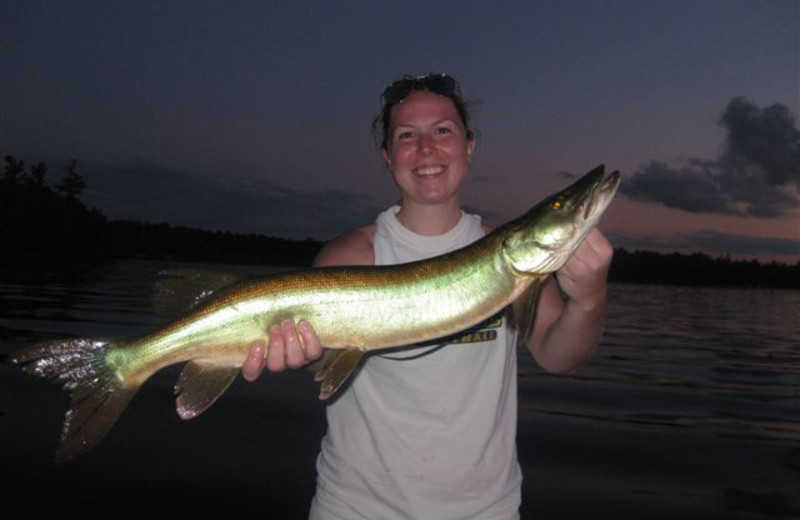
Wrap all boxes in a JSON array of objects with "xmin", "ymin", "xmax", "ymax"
[{"xmin": 242, "ymin": 320, "xmax": 322, "ymax": 381}]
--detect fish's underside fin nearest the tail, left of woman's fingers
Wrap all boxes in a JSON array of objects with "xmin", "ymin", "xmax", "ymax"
[{"xmin": 175, "ymin": 360, "xmax": 241, "ymax": 420}]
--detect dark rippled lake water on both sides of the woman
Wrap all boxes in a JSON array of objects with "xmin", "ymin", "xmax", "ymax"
[{"xmin": 0, "ymin": 261, "xmax": 800, "ymax": 519}]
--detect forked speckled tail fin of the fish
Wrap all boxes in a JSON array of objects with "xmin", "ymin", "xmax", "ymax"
[{"xmin": 11, "ymin": 339, "xmax": 139, "ymax": 462}]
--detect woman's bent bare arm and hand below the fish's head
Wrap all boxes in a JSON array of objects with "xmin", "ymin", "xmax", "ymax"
[{"xmin": 527, "ymin": 229, "xmax": 614, "ymax": 373}]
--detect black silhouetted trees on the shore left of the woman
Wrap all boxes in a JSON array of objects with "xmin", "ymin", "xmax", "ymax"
[{"xmin": 0, "ymin": 155, "xmax": 322, "ymax": 276}]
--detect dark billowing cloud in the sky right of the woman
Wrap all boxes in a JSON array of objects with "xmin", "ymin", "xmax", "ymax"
[{"xmin": 620, "ymin": 97, "xmax": 800, "ymax": 218}]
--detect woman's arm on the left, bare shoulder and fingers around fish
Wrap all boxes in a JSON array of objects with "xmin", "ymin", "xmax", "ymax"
[{"xmin": 242, "ymin": 225, "xmax": 375, "ymax": 381}]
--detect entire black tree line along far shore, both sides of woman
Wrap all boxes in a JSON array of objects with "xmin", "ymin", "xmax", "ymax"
[{"xmin": 0, "ymin": 155, "xmax": 800, "ymax": 289}]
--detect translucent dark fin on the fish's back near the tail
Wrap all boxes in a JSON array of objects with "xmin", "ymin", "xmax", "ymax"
[{"xmin": 152, "ymin": 269, "xmax": 241, "ymax": 317}]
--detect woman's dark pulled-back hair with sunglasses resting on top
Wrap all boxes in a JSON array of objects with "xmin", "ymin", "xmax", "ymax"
[{"xmin": 372, "ymin": 73, "xmax": 475, "ymax": 150}]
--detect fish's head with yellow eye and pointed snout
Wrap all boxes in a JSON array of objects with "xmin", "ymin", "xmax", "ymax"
[{"xmin": 503, "ymin": 165, "xmax": 620, "ymax": 274}]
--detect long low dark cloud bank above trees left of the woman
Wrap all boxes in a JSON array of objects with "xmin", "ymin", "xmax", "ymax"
[{"xmin": 83, "ymin": 160, "xmax": 383, "ymax": 239}]
